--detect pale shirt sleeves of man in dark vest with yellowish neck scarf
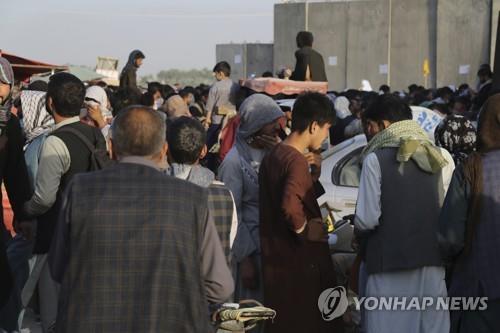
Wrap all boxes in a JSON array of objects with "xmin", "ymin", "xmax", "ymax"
[{"xmin": 354, "ymin": 148, "xmax": 455, "ymax": 230}]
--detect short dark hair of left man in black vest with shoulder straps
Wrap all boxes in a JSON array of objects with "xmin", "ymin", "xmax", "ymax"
[{"xmin": 47, "ymin": 72, "xmax": 85, "ymax": 118}]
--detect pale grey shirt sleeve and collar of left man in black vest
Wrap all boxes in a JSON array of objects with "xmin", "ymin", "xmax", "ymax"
[{"xmin": 24, "ymin": 116, "xmax": 80, "ymax": 216}]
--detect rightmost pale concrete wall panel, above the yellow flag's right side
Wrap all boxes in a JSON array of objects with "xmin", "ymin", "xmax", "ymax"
[{"xmin": 437, "ymin": 0, "xmax": 492, "ymax": 86}]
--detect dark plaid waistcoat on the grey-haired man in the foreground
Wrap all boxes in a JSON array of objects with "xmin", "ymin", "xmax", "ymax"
[{"xmin": 49, "ymin": 163, "xmax": 215, "ymax": 333}]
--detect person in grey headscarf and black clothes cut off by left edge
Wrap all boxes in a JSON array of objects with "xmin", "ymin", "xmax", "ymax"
[{"xmin": 0, "ymin": 57, "xmax": 31, "ymax": 332}]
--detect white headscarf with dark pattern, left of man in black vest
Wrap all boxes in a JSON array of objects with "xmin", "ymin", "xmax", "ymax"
[{"xmin": 21, "ymin": 90, "xmax": 54, "ymax": 143}]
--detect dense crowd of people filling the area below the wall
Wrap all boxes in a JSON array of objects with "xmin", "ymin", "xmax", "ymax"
[{"xmin": 0, "ymin": 32, "xmax": 500, "ymax": 333}]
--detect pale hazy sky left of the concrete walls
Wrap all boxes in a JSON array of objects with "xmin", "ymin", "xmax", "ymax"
[{"xmin": 0, "ymin": 0, "xmax": 277, "ymax": 75}]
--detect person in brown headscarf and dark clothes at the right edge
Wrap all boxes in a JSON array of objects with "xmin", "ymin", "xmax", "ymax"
[{"xmin": 439, "ymin": 94, "xmax": 500, "ymax": 333}]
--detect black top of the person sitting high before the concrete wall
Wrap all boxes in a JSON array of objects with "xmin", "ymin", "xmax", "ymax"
[{"xmin": 290, "ymin": 46, "xmax": 328, "ymax": 82}]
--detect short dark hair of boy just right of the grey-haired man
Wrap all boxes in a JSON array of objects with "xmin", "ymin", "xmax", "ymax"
[{"xmin": 167, "ymin": 117, "xmax": 207, "ymax": 165}]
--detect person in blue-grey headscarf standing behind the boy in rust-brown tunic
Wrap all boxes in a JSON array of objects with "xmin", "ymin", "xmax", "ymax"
[{"xmin": 218, "ymin": 94, "xmax": 285, "ymax": 301}]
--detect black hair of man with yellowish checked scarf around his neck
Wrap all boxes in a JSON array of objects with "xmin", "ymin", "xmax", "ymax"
[{"xmin": 363, "ymin": 94, "xmax": 413, "ymax": 123}]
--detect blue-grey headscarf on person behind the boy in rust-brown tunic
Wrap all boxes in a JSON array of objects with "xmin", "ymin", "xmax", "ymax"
[{"xmin": 236, "ymin": 94, "xmax": 285, "ymax": 164}]
